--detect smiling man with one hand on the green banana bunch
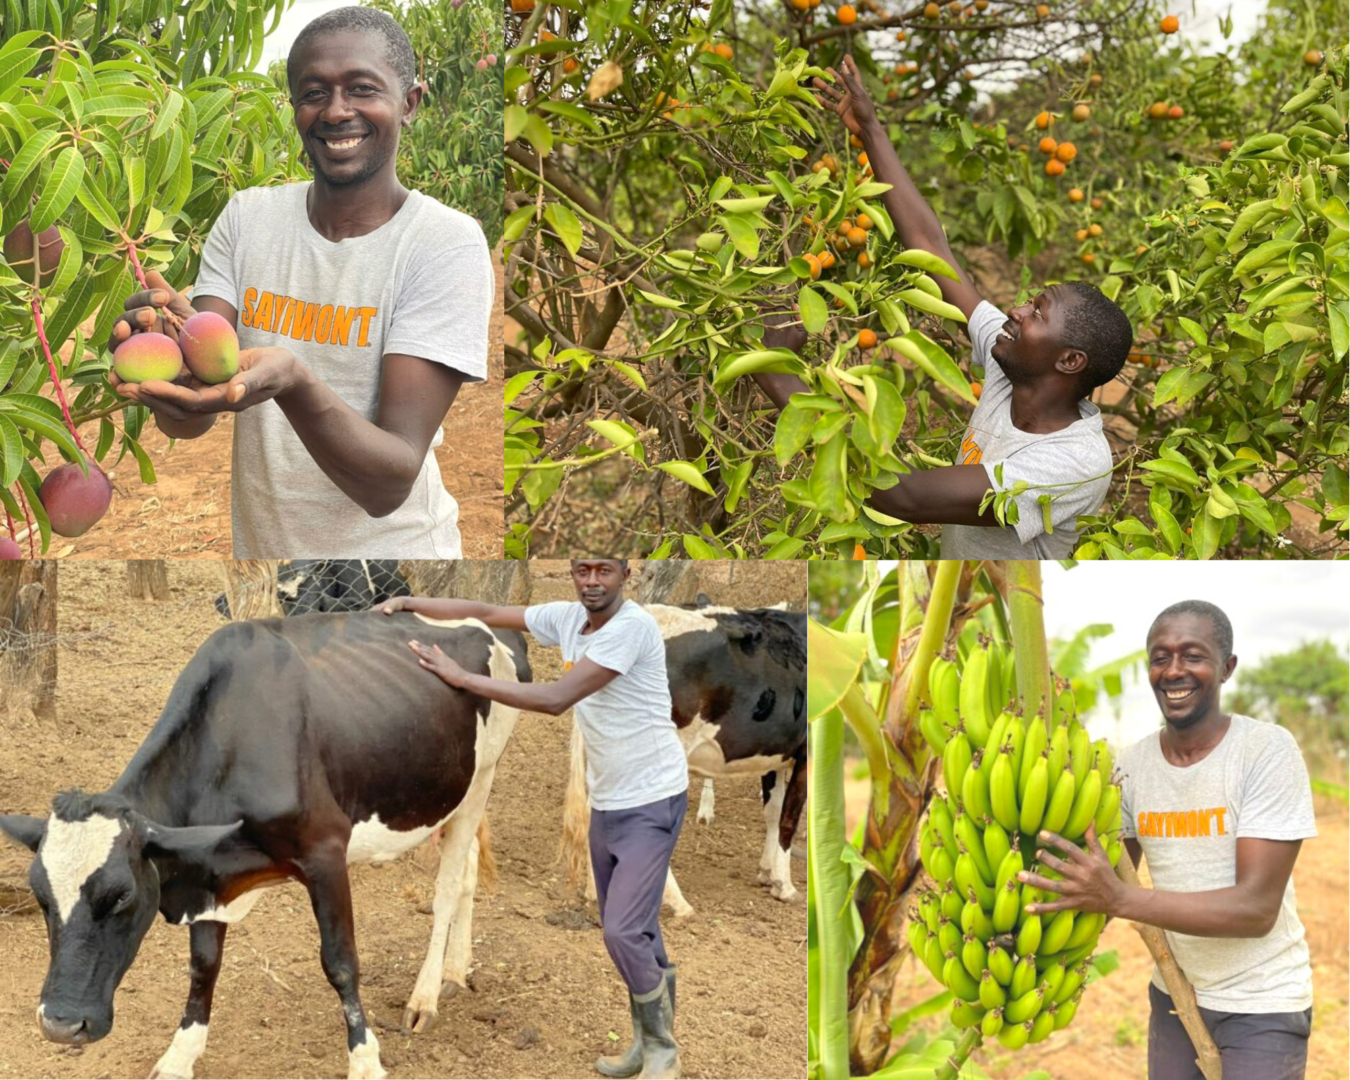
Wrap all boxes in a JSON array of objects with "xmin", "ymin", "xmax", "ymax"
[{"xmin": 1022, "ymin": 601, "xmax": 1318, "ymax": 1080}]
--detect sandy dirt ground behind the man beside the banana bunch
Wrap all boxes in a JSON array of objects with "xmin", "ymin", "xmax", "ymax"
[{"xmin": 848, "ymin": 766, "xmax": 1350, "ymax": 1080}]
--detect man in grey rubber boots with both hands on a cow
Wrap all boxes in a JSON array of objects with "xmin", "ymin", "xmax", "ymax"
[{"xmin": 381, "ymin": 559, "xmax": 689, "ymax": 1077}]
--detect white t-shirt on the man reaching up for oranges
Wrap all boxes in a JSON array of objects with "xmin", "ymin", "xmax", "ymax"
[{"xmin": 942, "ymin": 300, "xmax": 1111, "ymax": 559}]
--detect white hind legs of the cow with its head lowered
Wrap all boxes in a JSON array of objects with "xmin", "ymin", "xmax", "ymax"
[{"xmin": 404, "ymin": 799, "xmax": 491, "ymax": 1033}]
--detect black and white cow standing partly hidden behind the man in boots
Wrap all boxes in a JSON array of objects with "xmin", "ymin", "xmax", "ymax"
[{"xmin": 563, "ymin": 603, "xmax": 806, "ymax": 918}]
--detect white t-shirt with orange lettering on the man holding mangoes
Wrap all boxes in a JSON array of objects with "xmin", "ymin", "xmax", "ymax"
[{"xmin": 193, "ymin": 182, "xmax": 500, "ymax": 559}]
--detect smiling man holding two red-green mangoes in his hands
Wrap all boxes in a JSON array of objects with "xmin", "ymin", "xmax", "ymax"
[{"xmin": 109, "ymin": 7, "xmax": 493, "ymax": 559}]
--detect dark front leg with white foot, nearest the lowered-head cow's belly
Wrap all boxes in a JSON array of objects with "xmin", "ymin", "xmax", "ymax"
[{"xmin": 304, "ymin": 841, "xmax": 385, "ymax": 1080}]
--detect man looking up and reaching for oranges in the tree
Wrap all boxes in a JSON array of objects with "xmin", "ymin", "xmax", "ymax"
[{"xmin": 753, "ymin": 57, "xmax": 1133, "ymax": 559}]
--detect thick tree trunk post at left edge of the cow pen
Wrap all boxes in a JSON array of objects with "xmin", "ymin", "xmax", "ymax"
[{"xmin": 0, "ymin": 559, "xmax": 57, "ymax": 720}]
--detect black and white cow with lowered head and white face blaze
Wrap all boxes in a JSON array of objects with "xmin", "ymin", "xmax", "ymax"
[{"xmin": 0, "ymin": 612, "xmax": 531, "ymax": 1079}]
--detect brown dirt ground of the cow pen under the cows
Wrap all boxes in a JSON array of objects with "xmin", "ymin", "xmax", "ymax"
[{"xmin": 0, "ymin": 560, "xmax": 806, "ymax": 1077}]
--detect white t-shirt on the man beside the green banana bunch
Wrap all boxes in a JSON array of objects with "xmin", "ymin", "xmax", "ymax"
[{"xmin": 1119, "ymin": 713, "xmax": 1318, "ymax": 1013}]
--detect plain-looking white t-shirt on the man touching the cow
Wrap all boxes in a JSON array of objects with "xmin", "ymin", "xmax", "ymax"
[{"xmin": 525, "ymin": 599, "xmax": 689, "ymax": 810}]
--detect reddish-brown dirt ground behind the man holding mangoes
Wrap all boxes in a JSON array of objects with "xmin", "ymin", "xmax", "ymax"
[{"xmin": 39, "ymin": 246, "xmax": 504, "ymax": 559}]
